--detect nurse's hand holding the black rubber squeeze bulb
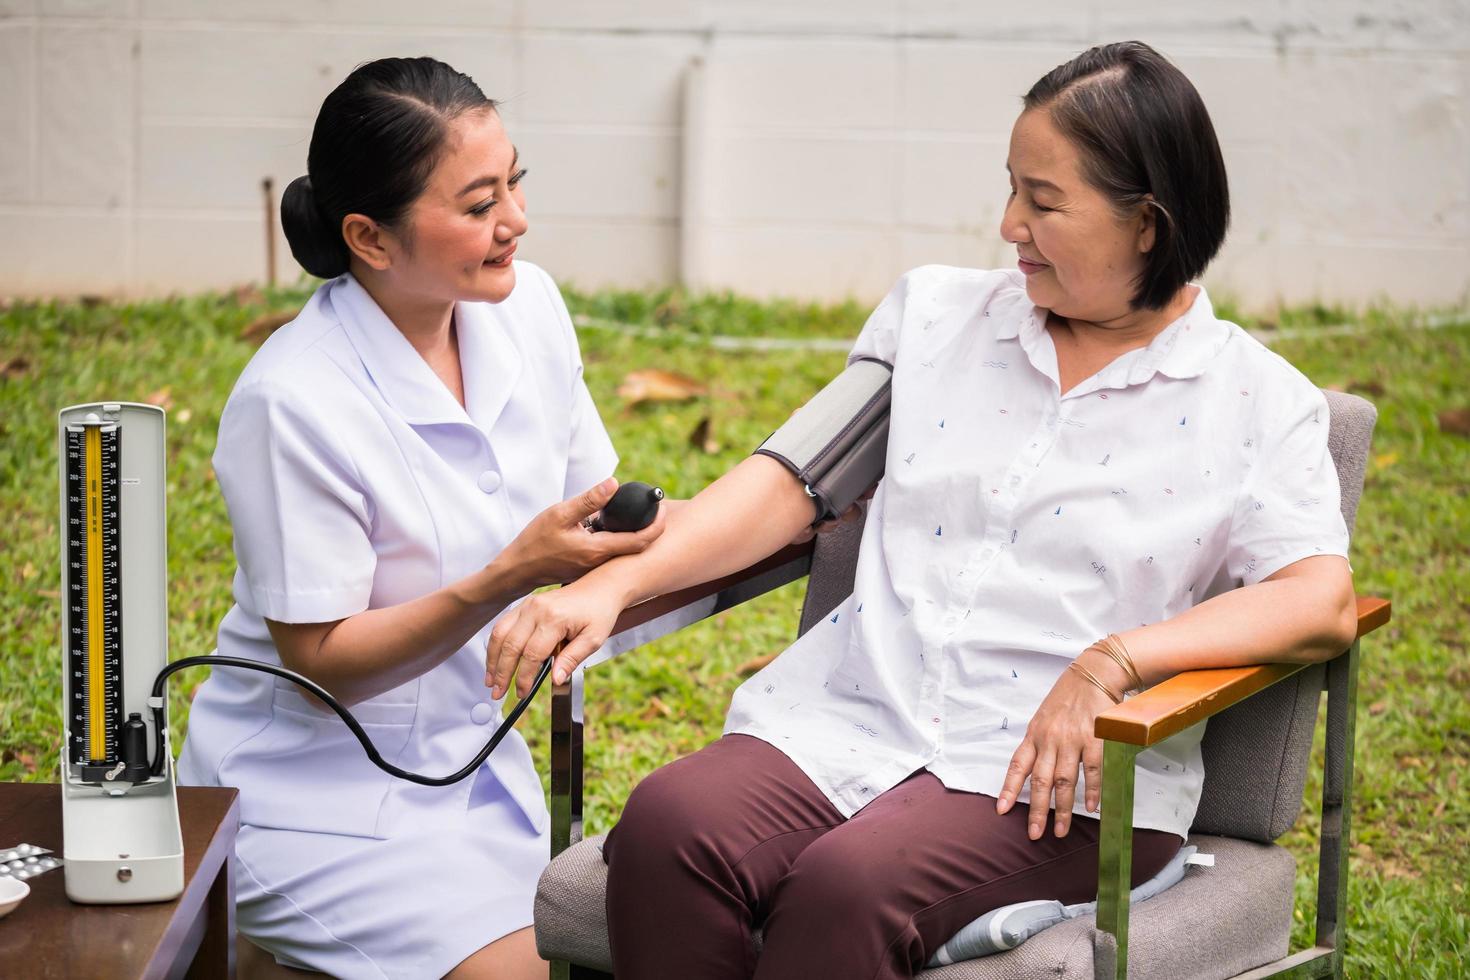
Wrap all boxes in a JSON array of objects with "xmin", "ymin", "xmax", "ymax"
[{"xmin": 495, "ymin": 476, "xmax": 664, "ymax": 595}]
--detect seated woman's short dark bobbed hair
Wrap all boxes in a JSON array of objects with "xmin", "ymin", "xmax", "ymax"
[{"xmin": 1025, "ymin": 41, "xmax": 1230, "ymax": 310}]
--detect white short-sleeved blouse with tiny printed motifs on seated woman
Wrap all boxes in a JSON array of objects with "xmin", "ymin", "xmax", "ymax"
[{"xmin": 725, "ymin": 266, "xmax": 1348, "ymax": 837}]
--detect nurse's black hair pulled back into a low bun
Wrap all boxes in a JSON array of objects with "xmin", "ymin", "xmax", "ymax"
[{"xmin": 281, "ymin": 57, "xmax": 495, "ymax": 279}]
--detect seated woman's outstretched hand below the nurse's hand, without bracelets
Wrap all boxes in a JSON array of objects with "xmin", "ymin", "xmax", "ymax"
[{"xmin": 485, "ymin": 580, "xmax": 625, "ymax": 698}]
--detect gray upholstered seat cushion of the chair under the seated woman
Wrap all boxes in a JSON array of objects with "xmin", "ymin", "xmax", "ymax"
[{"xmin": 535, "ymin": 836, "xmax": 1297, "ymax": 980}]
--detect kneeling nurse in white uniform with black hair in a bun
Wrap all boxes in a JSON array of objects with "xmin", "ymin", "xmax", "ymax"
[{"xmin": 179, "ymin": 57, "xmax": 663, "ymax": 980}]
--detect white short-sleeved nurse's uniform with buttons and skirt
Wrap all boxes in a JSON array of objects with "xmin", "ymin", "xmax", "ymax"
[{"xmin": 179, "ymin": 262, "xmax": 617, "ymax": 977}]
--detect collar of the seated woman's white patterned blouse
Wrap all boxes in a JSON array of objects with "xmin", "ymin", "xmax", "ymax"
[{"xmin": 997, "ymin": 284, "xmax": 1235, "ymax": 388}]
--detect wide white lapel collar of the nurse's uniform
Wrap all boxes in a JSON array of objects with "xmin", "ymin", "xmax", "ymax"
[{"xmin": 331, "ymin": 273, "xmax": 520, "ymax": 433}]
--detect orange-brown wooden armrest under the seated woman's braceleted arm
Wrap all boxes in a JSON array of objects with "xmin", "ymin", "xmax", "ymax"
[{"xmin": 1094, "ymin": 595, "xmax": 1392, "ymax": 746}]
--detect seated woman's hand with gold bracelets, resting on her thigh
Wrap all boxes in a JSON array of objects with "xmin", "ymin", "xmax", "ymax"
[{"xmin": 995, "ymin": 649, "xmax": 1127, "ymax": 840}]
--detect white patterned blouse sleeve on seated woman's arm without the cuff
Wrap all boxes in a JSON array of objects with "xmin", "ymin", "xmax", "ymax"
[{"xmin": 1226, "ymin": 376, "xmax": 1348, "ymax": 585}]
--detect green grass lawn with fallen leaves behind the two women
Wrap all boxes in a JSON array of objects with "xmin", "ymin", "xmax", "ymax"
[{"xmin": 0, "ymin": 282, "xmax": 1470, "ymax": 977}]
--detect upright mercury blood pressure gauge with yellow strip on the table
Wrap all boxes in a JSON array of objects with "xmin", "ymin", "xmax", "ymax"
[{"xmin": 57, "ymin": 403, "xmax": 184, "ymax": 904}]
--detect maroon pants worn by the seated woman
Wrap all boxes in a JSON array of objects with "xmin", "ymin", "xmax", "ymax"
[{"xmin": 603, "ymin": 735, "xmax": 1182, "ymax": 980}]
